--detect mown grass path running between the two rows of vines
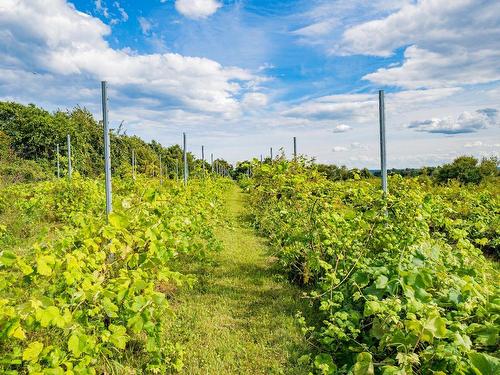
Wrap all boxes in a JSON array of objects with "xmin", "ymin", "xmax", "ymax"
[{"xmin": 167, "ymin": 186, "xmax": 307, "ymax": 374}]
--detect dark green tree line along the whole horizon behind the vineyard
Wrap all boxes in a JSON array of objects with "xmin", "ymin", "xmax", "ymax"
[{"xmin": 0, "ymin": 101, "xmax": 499, "ymax": 184}]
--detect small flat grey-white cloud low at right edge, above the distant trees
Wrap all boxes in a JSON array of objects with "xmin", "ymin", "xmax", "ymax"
[{"xmin": 408, "ymin": 108, "xmax": 499, "ymax": 134}]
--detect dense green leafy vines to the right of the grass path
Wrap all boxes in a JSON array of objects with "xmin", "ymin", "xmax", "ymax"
[{"xmin": 250, "ymin": 160, "xmax": 500, "ymax": 374}]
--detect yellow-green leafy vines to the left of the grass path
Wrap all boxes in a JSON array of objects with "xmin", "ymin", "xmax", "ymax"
[{"xmin": 0, "ymin": 176, "xmax": 225, "ymax": 374}]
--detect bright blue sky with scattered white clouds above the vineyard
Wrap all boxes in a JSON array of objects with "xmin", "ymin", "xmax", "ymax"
[{"xmin": 0, "ymin": 0, "xmax": 500, "ymax": 169}]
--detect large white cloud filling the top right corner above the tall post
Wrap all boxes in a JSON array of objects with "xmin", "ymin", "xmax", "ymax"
[{"xmin": 338, "ymin": 0, "xmax": 500, "ymax": 88}]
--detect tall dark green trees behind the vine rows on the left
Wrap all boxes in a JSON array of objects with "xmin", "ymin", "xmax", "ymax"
[{"xmin": 0, "ymin": 102, "xmax": 223, "ymax": 181}]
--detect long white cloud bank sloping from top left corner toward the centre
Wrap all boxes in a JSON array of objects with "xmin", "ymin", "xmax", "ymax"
[{"xmin": 0, "ymin": 0, "xmax": 266, "ymax": 116}]
